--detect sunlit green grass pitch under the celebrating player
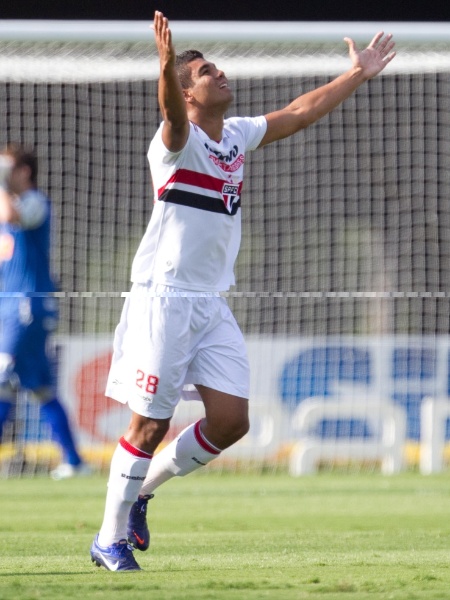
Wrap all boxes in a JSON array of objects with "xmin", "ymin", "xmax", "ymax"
[{"xmin": 0, "ymin": 473, "xmax": 450, "ymax": 600}]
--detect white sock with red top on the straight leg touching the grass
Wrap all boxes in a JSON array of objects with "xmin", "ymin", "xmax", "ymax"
[{"xmin": 98, "ymin": 437, "xmax": 152, "ymax": 547}]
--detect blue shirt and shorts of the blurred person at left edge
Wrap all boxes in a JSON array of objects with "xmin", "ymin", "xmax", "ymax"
[{"xmin": 0, "ymin": 189, "xmax": 58, "ymax": 389}]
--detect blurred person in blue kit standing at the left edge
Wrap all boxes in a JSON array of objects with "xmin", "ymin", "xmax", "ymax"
[{"xmin": 0, "ymin": 143, "xmax": 90, "ymax": 479}]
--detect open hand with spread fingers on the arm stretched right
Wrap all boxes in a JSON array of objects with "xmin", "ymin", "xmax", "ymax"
[{"xmin": 344, "ymin": 31, "xmax": 395, "ymax": 79}]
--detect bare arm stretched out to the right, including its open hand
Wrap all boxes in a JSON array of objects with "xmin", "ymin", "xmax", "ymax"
[{"xmin": 260, "ymin": 31, "xmax": 395, "ymax": 147}]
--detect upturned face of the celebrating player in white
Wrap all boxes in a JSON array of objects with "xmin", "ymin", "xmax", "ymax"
[{"xmin": 185, "ymin": 58, "xmax": 233, "ymax": 110}]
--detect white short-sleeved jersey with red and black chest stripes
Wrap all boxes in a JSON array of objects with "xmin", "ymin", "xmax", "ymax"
[{"xmin": 131, "ymin": 116, "xmax": 267, "ymax": 291}]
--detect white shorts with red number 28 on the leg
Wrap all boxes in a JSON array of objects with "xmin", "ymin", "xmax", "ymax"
[{"xmin": 105, "ymin": 284, "xmax": 250, "ymax": 419}]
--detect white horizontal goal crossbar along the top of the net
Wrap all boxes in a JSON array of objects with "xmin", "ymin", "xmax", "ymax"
[{"xmin": 0, "ymin": 19, "xmax": 450, "ymax": 43}]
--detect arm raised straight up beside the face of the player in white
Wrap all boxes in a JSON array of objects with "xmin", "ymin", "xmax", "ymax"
[{"xmin": 153, "ymin": 11, "xmax": 189, "ymax": 152}]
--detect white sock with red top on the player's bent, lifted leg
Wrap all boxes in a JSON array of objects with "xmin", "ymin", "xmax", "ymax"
[{"xmin": 140, "ymin": 421, "xmax": 220, "ymax": 496}]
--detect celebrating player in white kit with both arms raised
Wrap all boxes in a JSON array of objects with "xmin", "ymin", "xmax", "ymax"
[{"xmin": 91, "ymin": 11, "xmax": 395, "ymax": 571}]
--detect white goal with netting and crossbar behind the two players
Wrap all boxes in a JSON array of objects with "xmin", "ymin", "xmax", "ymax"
[{"xmin": 0, "ymin": 22, "xmax": 450, "ymax": 476}]
